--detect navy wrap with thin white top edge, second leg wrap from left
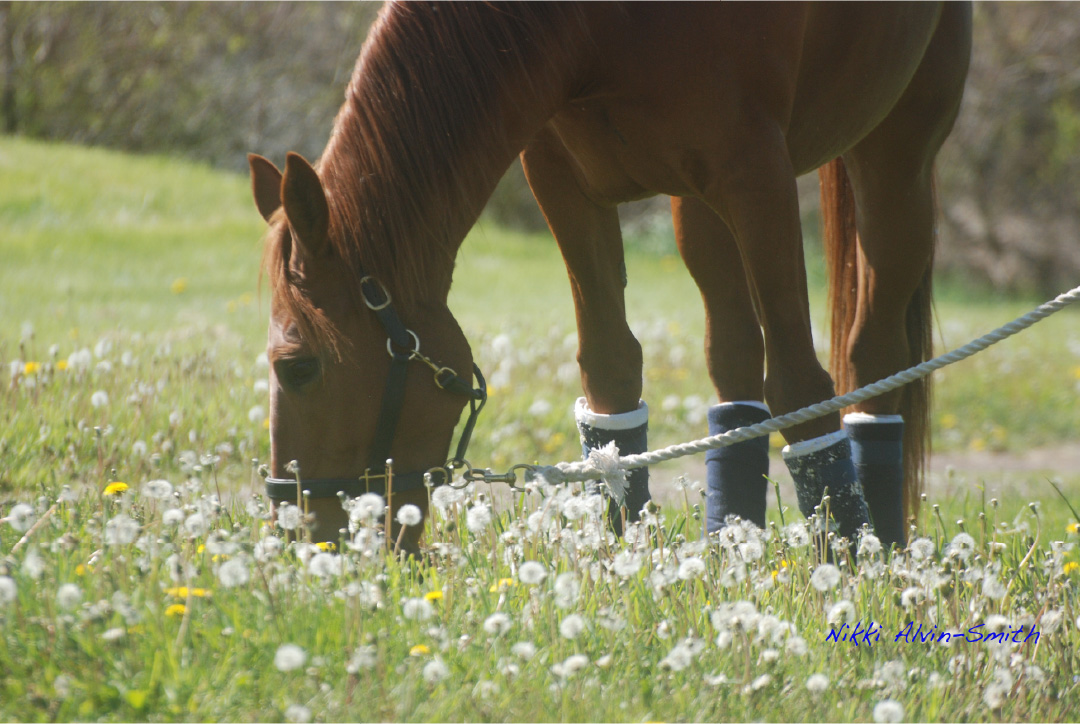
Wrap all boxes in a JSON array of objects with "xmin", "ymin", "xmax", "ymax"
[{"xmin": 705, "ymin": 402, "xmax": 770, "ymax": 533}]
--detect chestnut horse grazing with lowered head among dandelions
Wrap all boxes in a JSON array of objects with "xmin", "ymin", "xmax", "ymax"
[{"xmin": 249, "ymin": 2, "xmax": 971, "ymax": 549}]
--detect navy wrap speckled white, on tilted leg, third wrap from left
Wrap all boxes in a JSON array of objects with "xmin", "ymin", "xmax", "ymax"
[{"xmin": 784, "ymin": 431, "xmax": 869, "ymax": 540}]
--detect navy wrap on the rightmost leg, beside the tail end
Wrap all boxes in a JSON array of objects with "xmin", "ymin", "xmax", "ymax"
[{"xmin": 843, "ymin": 413, "xmax": 906, "ymax": 550}]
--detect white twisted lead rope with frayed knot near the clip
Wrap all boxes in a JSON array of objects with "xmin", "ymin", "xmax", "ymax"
[{"xmin": 532, "ymin": 286, "xmax": 1080, "ymax": 492}]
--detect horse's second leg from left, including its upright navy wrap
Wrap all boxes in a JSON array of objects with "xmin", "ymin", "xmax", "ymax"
[{"xmin": 672, "ymin": 197, "xmax": 769, "ymax": 533}]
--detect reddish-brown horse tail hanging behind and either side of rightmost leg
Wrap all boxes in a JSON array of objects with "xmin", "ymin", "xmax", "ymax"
[{"xmin": 818, "ymin": 158, "xmax": 933, "ymax": 523}]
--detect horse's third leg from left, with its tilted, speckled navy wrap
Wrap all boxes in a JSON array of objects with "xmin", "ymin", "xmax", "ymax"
[{"xmin": 704, "ymin": 136, "xmax": 869, "ymax": 538}]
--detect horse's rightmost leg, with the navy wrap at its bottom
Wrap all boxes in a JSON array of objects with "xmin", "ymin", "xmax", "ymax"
[{"xmin": 835, "ymin": 0, "xmax": 970, "ymax": 546}]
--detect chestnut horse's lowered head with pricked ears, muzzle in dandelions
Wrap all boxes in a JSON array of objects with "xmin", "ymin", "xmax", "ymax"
[{"xmin": 248, "ymin": 153, "xmax": 483, "ymax": 550}]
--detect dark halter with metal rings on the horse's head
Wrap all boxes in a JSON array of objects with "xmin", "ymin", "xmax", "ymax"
[{"xmin": 266, "ymin": 277, "xmax": 487, "ymax": 499}]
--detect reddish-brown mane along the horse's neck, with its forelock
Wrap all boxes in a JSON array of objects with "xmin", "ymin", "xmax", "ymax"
[{"xmin": 266, "ymin": 2, "xmax": 588, "ymax": 345}]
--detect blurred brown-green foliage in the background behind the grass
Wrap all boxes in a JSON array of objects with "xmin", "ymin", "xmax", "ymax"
[{"xmin": 0, "ymin": 1, "xmax": 1080, "ymax": 294}]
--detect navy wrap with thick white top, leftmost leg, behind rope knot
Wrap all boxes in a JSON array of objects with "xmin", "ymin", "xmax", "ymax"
[{"xmin": 575, "ymin": 398, "xmax": 651, "ymax": 535}]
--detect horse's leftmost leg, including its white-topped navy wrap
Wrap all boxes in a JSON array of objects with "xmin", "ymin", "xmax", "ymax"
[{"xmin": 522, "ymin": 132, "xmax": 649, "ymax": 531}]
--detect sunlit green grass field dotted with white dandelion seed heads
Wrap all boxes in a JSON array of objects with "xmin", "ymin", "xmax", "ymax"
[{"xmin": 0, "ymin": 137, "xmax": 1080, "ymax": 721}]
